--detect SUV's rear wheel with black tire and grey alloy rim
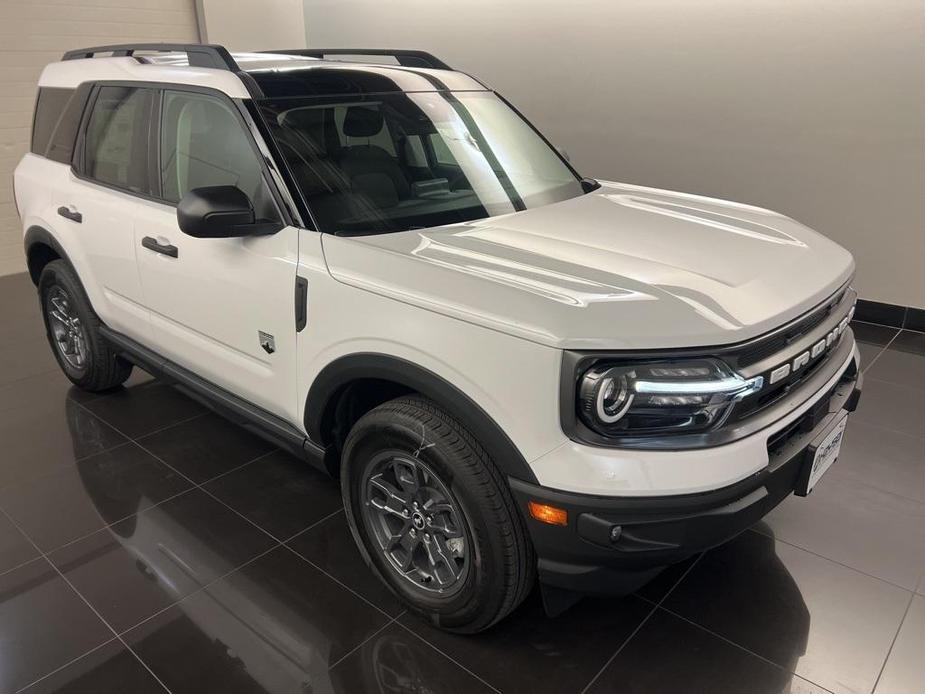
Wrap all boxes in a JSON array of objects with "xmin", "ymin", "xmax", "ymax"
[{"xmin": 39, "ymin": 260, "xmax": 132, "ymax": 392}]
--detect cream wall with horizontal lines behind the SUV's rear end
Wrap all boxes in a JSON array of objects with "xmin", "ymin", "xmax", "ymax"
[{"xmin": 0, "ymin": 0, "xmax": 199, "ymax": 275}]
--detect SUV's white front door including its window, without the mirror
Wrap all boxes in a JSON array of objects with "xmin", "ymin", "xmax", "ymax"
[{"xmin": 135, "ymin": 89, "xmax": 299, "ymax": 421}]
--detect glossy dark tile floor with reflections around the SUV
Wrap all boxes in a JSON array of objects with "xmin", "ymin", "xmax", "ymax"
[{"xmin": 0, "ymin": 275, "xmax": 925, "ymax": 694}]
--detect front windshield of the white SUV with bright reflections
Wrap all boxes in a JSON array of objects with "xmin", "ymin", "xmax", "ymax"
[{"xmin": 260, "ymin": 91, "xmax": 582, "ymax": 234}]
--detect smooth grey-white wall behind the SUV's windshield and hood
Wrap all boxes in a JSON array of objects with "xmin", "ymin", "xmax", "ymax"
[{"xmin": 305, "ymin": 0, "xmax": 925, "ymax": 307}]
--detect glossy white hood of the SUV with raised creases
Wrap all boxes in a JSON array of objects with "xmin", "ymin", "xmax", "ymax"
[{"xmin": 323, "ymin": 182, "xmax": 854, "ymax": 349}]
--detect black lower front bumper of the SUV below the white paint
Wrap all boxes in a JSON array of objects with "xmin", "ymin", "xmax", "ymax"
[{"xmin": 510, "ymin": 359, "xmax": 861, "ymax": 594}]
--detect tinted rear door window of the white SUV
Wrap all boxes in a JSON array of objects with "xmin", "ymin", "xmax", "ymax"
[{"xmin": 85, "ymin": 87, "xmax": 152, "ymax": 193}]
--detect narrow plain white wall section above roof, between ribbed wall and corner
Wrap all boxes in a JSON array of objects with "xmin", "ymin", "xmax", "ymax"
[{"xmin": 196, "ymin": 0, "xmax": 305, "ymax": 51}]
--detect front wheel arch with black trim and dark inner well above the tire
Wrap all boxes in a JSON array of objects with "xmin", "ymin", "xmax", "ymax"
[{"xmin": 304, "ymin": 352, "xmax": 537, "ymax": 484}]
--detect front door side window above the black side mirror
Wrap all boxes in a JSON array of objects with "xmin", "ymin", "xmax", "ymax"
[{"xmin": 160, "ymin": 91, "xmax": 276, "ymax": 219}]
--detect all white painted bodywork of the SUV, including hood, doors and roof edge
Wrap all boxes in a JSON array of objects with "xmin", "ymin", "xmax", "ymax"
[{"xmin": 16, "ymin": 56, "xmax": 857, "ymax": 496}]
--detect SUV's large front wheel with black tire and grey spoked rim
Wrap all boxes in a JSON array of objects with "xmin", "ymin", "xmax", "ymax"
[{"xmin": 341, "ymin": 396, "xmax": 536, "ymax": 633}]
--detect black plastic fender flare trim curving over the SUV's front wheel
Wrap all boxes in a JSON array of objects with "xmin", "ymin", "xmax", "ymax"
[{"xmin": 304, "ymin": 352, "xmax": 538, "ymax": 484}]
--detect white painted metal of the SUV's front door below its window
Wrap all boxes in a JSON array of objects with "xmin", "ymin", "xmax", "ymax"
[{"xmin": 134, "ymin": 200, "xmax": 304, "ymax": 420}]
